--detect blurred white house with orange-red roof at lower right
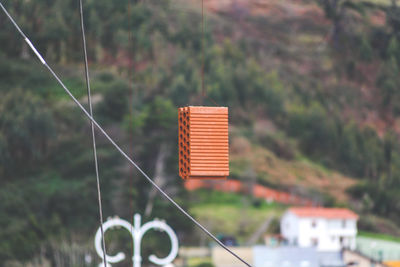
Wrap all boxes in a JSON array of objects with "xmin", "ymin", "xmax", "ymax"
[{"xmin": 280, "ymin": 207, "xmax": 358, "ymax": 251}]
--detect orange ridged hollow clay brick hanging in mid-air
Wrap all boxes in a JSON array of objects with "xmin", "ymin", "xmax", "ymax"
[{"xmin": 179, "ymin": 107, "xmax": 229, "ymax": 179}]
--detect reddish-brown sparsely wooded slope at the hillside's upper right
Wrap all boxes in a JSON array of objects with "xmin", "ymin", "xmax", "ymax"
[{"xmin": 205, "ymin": 0, "xmax": 394, "ymax": 136}]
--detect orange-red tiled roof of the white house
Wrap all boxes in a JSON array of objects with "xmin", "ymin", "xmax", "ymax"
[{"xmin": 289, "ymin": 207, "xmax": 358, "ymax": 219}]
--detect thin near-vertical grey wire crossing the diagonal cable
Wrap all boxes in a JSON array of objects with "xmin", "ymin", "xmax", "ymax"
[{"xmin": 79, "ymin": 0, "xmax": 107, "ymax": 267}]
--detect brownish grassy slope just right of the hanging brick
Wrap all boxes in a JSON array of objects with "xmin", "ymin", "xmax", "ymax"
[{"xmin": 231, "ymin": 133, "xmax": 357, "ymax": 204}]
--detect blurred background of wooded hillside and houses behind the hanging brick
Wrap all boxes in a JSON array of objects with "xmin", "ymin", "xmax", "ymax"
[{"xmin": 0, "ymin": 0, "xmax": 400, "ymax": 267}]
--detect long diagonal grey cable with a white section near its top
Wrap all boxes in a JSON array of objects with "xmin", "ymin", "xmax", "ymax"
[{"xmin": 0, "ymin": 2, "xmax": 251, "ymax": 267}]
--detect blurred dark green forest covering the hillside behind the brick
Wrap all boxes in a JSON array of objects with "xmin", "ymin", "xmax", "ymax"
[{"xmin": 0, "ymin": 0, "xmax": 400, "ymax": 266}]
